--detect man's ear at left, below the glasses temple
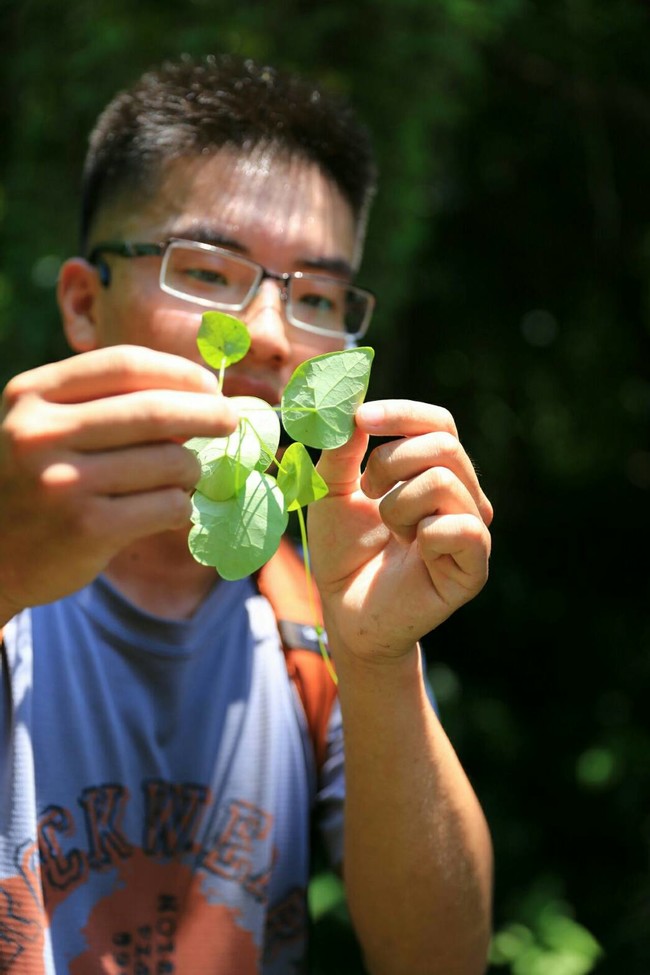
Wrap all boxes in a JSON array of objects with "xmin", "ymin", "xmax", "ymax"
[{"xmin": 56, "ymin": 257, "xmax": 102, "ymax": 352}]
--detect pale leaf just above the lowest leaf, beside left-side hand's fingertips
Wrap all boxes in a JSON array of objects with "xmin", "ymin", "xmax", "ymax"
[{"xmin": 185, "ymin": 419, "xmax": 261, "ymax": 501}]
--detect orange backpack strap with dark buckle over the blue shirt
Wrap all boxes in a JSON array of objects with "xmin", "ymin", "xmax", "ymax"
[{"xmin": 257, "ymin": 537, "xmax": 336, "ymax": 769}]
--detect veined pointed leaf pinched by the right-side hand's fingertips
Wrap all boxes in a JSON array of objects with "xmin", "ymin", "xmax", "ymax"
[{"xmin": 282, "ymin": 346, "xmax": 375, "ymax": 449}]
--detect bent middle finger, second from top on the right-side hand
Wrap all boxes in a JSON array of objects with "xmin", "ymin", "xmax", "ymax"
[{"xmin": 361, "ymin": 432, "xmax": 492, "ymax": 520}]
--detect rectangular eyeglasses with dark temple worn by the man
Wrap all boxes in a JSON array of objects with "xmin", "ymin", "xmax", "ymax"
[{"xmin": 88, "ymin": 238, "xmax": 375, "ymax": 339}]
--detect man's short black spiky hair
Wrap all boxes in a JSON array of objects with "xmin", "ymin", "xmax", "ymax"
[{"xmin": 81, "ymin": 54, "xmax": 377, "ymax": 253}]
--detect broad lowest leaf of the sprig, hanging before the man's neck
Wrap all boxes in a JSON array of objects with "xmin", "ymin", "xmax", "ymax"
[{"xmin": 188, "ymin": 471, "xmax": 288, "ymax": 580}]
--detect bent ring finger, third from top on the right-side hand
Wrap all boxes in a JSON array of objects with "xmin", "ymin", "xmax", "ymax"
[{"xmin": 379, "ymin": 467, "xmax": 481, "ymax": 545}]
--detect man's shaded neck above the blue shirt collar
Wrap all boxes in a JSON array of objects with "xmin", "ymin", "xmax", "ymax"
[{"xmin": 105, "ymin": 530, "xmax": 219, "ymax": 619}]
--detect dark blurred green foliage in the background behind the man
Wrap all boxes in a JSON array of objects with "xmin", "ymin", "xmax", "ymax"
[{"xmin": 0, "ymin": 0, "xmax": 650, "ymax": 975}]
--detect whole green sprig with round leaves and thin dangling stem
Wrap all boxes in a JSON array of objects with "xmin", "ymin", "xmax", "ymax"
[{"xmin": 185, "ymin": 311, "xmax": 374, "ymax": 680}]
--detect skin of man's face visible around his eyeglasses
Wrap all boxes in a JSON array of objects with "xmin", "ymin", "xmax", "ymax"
[{"xmin": 77, "ymin": 150, "xmax": 357, "ymax": 403}]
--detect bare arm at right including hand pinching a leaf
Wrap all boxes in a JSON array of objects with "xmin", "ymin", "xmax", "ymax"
[{"xmin": 309, "ymin": 401, "xmax": 492, "ymax": 975}]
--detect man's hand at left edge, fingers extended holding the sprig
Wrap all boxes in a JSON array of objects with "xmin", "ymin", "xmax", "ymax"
[{"xmin": 0, "ymin": 346, "xmax": 237, "ymax": 626}]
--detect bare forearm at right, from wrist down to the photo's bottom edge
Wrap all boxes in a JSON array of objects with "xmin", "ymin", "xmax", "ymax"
[{"xmin": 337, "ymin": 640, "xmax": 492, "ymax": 975}]
